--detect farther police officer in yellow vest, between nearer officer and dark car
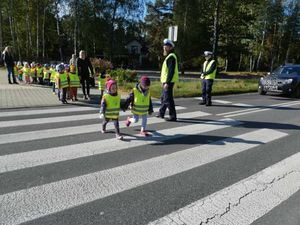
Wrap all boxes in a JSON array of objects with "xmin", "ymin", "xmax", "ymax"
[{"xmin": 199, "ymin": 51, "xmax": 217, "ymax": 106}]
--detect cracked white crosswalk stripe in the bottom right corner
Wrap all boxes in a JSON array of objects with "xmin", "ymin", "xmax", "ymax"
[{"xmin": 149, "ymin": 150, "xmax": 300, "ymax": 225}]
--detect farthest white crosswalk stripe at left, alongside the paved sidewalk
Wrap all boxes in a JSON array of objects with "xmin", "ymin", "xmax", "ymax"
[{"xmin": 0, "ymin": 106, "xmax": 99, "ymax": 117}]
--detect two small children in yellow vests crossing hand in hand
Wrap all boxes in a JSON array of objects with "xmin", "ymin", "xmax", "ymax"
[{"xmin": 100, "ymin": 76, "xmax": 153, "ymax": 140}]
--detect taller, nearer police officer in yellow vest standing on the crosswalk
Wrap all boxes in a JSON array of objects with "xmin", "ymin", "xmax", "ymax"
[{"xmin": 156, "ymin": 39, "xmax": 179, "ymax": 121}]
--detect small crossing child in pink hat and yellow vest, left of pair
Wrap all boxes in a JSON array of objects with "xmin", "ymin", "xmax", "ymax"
[{"xmin": 100, "ymin": 79, "xmax": 123, "ymax": 140}]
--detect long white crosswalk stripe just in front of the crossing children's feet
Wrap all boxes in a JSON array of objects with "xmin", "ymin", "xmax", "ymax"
[{"xmin": 0, "ymin": 119, "xmax": 240, "ymax": 173}]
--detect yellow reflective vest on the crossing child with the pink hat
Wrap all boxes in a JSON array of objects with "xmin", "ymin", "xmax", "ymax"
[{"xmin": 103, "ymin": 93, "xmax": 121, "ymax": 119}]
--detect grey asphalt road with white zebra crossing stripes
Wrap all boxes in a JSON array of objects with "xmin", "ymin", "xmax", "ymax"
[{"xmin": 0, "ymin": 94, "xmax": 300, "ymax": 225}]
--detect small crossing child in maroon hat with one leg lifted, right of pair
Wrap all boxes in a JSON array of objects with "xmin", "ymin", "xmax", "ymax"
[{"xmin": 124, "ymin": 76, "xmax": 153, "ymax": 137}]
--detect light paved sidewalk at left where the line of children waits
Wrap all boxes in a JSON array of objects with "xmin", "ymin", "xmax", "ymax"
[{"xmin": 0, "ymin": 67, "xmax": 108, "ymax": 110}]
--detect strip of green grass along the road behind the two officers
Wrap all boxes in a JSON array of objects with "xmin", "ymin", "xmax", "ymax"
[{"xmin": 119, "ymin": 79, "xmax": 258, "ymax": 98}]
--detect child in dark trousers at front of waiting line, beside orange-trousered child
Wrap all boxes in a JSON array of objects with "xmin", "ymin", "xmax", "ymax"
[{"xmin": 56, "ymin": 64, "xmax": 69, "ymax": 104}]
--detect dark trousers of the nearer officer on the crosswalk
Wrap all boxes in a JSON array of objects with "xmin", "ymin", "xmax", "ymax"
[{"xmin": 159, "ymin": 83, "xmax": 177, "ymax": 119}]
